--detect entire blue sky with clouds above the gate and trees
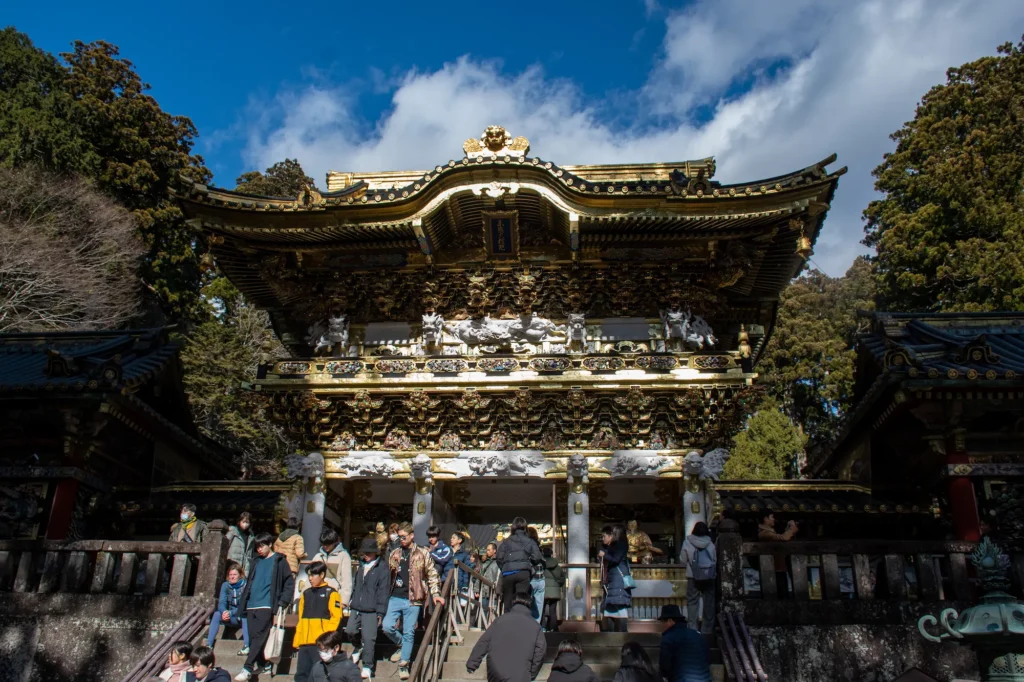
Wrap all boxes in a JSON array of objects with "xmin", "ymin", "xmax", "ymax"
[{"xmin": 0, "ymin": 0, "xmax": 1024, "ymax": 274}]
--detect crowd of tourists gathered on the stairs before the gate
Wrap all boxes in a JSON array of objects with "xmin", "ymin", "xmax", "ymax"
[{"xmin": 161, "ymin": 505, "xmax": 724, "ymax": 682}]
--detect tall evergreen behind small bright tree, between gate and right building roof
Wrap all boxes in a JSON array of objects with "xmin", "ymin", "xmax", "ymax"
[{"xmin": 757, "ymin": 258, "xmax": 874, "ymax": 442}]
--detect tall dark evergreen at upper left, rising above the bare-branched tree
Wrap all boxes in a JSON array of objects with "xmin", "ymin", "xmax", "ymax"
[{"xmin": 0, "ymin": 28, "xmax": 211, "ymax": 322}]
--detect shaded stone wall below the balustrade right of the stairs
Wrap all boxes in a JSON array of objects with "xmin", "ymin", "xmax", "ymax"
[{"xmin": 750, "ymin": 625, "xmax": 980, "ymax": 682}]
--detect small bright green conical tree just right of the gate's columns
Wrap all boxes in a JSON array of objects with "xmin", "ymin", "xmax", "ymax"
[{"xmin": 723, "ymin": 397, "xmax": 807, "ymax": 480}]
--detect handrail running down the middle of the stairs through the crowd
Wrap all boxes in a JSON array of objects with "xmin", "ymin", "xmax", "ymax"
[{"xmin": 410, "ymin": 561, "xmax": 502, "ymax": 682}]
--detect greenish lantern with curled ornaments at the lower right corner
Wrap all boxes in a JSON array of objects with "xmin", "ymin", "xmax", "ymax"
[{"xmin": 918, "ymin": 538, "xmax": 1024, "ymax": 682}]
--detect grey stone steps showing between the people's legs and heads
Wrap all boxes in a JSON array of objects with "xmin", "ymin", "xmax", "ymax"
[{"xmin": 203, "ymin": 627, "xmax": 734, "ymax": 682}]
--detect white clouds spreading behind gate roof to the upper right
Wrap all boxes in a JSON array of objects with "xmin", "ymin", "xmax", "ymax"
[{"xmin": 234, "ymin": 0, "xmax": 1024, "ymax": 274}]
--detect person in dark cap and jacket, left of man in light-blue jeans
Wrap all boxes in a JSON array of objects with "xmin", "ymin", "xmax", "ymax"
[{"xmin": 345, "ymin": 538, "xmax": 391, "ymax": 680}]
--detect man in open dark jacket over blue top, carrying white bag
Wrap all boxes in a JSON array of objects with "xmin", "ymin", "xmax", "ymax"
[{"xmin": 234, "ymin": 532, "xmax": 295, "ymax": 682}]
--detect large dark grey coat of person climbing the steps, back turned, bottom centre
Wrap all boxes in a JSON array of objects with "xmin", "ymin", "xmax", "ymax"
[{"xmin": 466, "ymin": 604, "xmax": 548, "ymax": 682}]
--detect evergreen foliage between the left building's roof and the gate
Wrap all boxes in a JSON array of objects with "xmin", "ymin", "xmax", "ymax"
[{"xmin": 181, "ymin": 290, "xmax": 295, "ymax": 477}]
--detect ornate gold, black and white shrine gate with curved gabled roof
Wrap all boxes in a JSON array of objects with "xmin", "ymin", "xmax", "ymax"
[{"xmin": 176, "ymin": 126, "xmax": 845, "ymax": 619}]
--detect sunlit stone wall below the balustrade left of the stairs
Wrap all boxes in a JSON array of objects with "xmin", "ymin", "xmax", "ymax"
[{"xmin": 0, "ymin": 594, "xmax": 197, "ymax": 682}]
